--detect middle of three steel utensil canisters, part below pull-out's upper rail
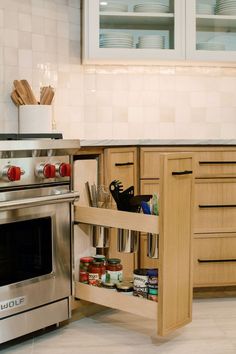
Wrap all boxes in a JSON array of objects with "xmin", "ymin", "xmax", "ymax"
[{"xmin": 117, "ymin": 229, "xmax": 139, "ymax": 253}]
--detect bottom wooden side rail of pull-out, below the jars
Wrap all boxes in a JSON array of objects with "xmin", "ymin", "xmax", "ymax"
[{"xmin": 75, "ymin": 282, "xmax": 158, "ymax": 319}]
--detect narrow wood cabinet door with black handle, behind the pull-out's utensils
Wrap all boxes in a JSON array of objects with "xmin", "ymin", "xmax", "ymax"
[{"xmin": 104, "ymin": 147, "xmax": 138, "ymax": 279}]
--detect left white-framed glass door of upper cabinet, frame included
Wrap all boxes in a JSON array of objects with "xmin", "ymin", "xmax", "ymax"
[{"xmin": 83, "ymin": 0, "xmax": 185, "ymax": 63}]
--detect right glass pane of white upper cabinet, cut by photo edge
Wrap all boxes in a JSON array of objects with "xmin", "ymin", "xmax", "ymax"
[{"xmin": 195, "ymin": 0, "xmax": 236, "ymax": 52}]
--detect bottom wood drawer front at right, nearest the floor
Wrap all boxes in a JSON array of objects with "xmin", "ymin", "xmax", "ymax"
[{"xmin": 193, "ymin": 237, "xmax": 236, "ymax": 286}]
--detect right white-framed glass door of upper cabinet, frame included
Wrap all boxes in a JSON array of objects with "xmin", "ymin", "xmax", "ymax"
[{"xmin": 186, "ymin": 0, "xmax": 236, "ymax": 62}]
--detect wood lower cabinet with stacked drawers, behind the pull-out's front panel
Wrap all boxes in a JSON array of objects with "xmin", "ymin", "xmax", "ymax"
[{"xmin": 140, "ymin": 145, "xmax": 236, "ymax": 288}]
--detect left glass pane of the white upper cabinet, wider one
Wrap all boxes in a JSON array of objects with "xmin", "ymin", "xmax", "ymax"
[{"xmin": 99, "ymin": 0, "xmax": 175, "ymax": 51}]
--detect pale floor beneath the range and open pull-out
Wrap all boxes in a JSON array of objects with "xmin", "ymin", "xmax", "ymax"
[{"xmin": 0, "ymin": 298, "xmax": 236, "ymax": 354}]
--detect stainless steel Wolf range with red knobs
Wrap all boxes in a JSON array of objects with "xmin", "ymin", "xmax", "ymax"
[{"xmin": 0, "ymin": 139, "xmax": 79, "ymax": 343}]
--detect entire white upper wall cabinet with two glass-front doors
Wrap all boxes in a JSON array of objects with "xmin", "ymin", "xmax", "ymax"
[{"xmin": 83, "ymin": 0, "xmax": 236, "ymax": 65}]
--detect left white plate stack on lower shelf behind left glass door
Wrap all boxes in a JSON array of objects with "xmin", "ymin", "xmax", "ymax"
[{"xmin": 99, "ymin": 31, "xmax": 133, "ymax": 48}]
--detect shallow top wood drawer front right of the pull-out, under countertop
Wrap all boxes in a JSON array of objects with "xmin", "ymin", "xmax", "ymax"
[{"xmin": 195, "ymin": 151, "xmax": 236, "ymax": 177}]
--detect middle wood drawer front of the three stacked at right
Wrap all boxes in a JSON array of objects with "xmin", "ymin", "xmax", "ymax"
[{"xmin": 194, "ymin": 179, "xmax": 236, "ymax": 233}]
